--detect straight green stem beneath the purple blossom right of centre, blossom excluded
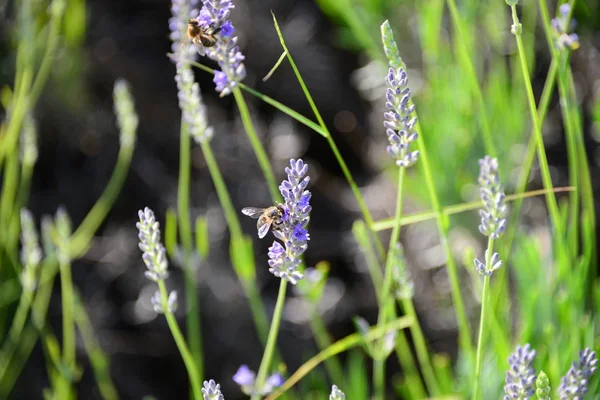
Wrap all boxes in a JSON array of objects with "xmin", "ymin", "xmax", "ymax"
[{"xmin": 373, "ymin": 167, "xmax": 406, "ymax": 400}]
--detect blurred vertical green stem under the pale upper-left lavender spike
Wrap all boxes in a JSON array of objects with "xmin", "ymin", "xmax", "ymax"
[{"xmin": 177, "ymin": 122, "xmax": 204, "ymax": 381}]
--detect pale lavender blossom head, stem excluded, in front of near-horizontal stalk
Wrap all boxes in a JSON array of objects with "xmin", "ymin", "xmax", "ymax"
[{"xmin": 478, "ymin": 156, "xmax": 508, "ymax": 239}]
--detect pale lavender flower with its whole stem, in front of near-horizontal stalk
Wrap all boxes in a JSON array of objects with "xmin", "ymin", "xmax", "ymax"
[{"xmin": 473, "ymin": 156, "xmax": 506, "ymax": 400}]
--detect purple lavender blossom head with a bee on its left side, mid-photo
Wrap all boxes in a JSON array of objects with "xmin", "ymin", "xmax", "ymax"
[{"xmin": 268, "ymin": 159, "xmax": 311, "ymax": 285}]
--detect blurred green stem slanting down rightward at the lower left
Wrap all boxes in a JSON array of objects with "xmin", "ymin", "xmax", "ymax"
[{"xmin": 75, "ymin": 295, "xmax": 119, "ymax": 400}]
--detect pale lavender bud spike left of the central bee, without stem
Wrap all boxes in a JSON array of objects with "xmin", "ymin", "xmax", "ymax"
[{"xmin": 136, "ymin": 207, "xmax": 169, "ymax": 282}]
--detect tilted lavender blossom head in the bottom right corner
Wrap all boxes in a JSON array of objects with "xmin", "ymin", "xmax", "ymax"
[{"xmin": 558, "ymin": 348, "xmax": 598, "ymax": 400}]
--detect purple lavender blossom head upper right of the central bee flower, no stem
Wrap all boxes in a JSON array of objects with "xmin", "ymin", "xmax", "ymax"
[{"xmin": 383, "ymin": 67, "xmax": 419, "ymax": 167}]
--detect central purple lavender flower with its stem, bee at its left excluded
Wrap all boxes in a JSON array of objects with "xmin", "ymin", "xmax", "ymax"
[{"xmin": 252, "ymin": 159, "xmax": 311, "ymax": 400}]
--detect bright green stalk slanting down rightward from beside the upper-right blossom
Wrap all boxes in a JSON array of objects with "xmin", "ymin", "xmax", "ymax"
[{"xmin": 415, "ymin": 122, "xmax": 473, "ymax": 360}]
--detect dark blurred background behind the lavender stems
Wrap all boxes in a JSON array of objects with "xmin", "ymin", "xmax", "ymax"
[{"xmin": 0, "ymin": 0, "xmax": 600, "ymax": 399}]
